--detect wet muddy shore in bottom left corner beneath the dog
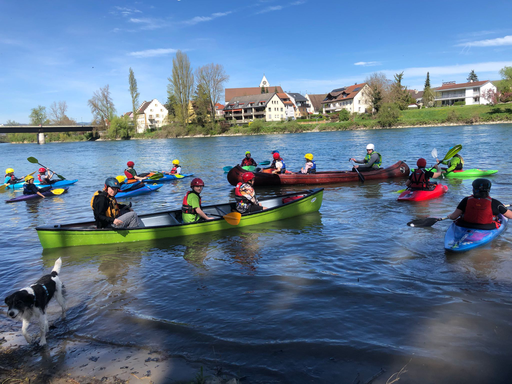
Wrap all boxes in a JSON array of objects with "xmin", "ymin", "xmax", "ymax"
[{"xmin": 0, "ymin": 321, "xmax": 239, "ymax": 384}]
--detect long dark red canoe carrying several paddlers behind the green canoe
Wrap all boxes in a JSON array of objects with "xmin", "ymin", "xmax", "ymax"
[{"xmin": 228, "ymin": 161, "xmax": 409, "ymax": 186}]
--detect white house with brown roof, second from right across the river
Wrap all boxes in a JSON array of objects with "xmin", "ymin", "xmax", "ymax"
[{"xmin": 322, "ymin": 83, "xmax": 371, "ymax": 113}]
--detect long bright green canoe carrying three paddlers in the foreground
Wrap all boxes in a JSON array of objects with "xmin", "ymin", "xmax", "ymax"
[{"xmin": 36, "ymin": 188, "xmax": 324, "ymax": 249}]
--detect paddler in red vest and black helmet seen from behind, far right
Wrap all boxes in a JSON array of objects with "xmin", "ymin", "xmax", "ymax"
[{"xmin": 447, "ymin": 179, "xmax": 512, "ymax": 229}]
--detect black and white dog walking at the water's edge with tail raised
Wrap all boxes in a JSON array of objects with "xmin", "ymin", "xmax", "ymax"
[{"xmin": 5, "ymin": 258, "xmax": 66, "ymax": 346}]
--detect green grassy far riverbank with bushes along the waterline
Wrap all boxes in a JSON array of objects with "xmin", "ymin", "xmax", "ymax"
[{"xmin": 6, "ymin": 103, "xmax": 512, "ymax": 143}]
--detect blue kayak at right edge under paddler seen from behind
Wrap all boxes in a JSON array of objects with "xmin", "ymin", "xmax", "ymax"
[{"xmin": 444, "ymin": 214, "xmax": 508, "ymax": 252}]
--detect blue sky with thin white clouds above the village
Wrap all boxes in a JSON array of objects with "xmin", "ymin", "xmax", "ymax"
[{"xmin": 0, "ymin": 0, "xmax": 512, "ymax": 124}]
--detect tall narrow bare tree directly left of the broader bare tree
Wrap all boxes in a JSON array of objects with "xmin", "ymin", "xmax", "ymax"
[{"xmin": 167, "ymin": 50, "xmax": 194, "ymax": 126}]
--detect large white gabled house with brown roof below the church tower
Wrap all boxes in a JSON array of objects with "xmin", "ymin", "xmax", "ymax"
[{"xmin": 224, "ymin": 93, "xmax": 286, "ymax": 124}]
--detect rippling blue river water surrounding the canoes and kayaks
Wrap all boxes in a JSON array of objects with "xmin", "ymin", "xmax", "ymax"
[{"xmin": 0, "ymin": 124, "xmax": 512, "ymax": 383}]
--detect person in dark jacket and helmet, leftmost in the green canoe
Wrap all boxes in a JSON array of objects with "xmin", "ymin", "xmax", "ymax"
[{"xmin": 91, "ymin": 177, "xmax": 139, "ymax": 229}]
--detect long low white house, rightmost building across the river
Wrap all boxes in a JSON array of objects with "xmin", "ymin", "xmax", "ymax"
[{"xmin": 434, "ymin": 80, "xmax": 497, "ymax": 106}]
